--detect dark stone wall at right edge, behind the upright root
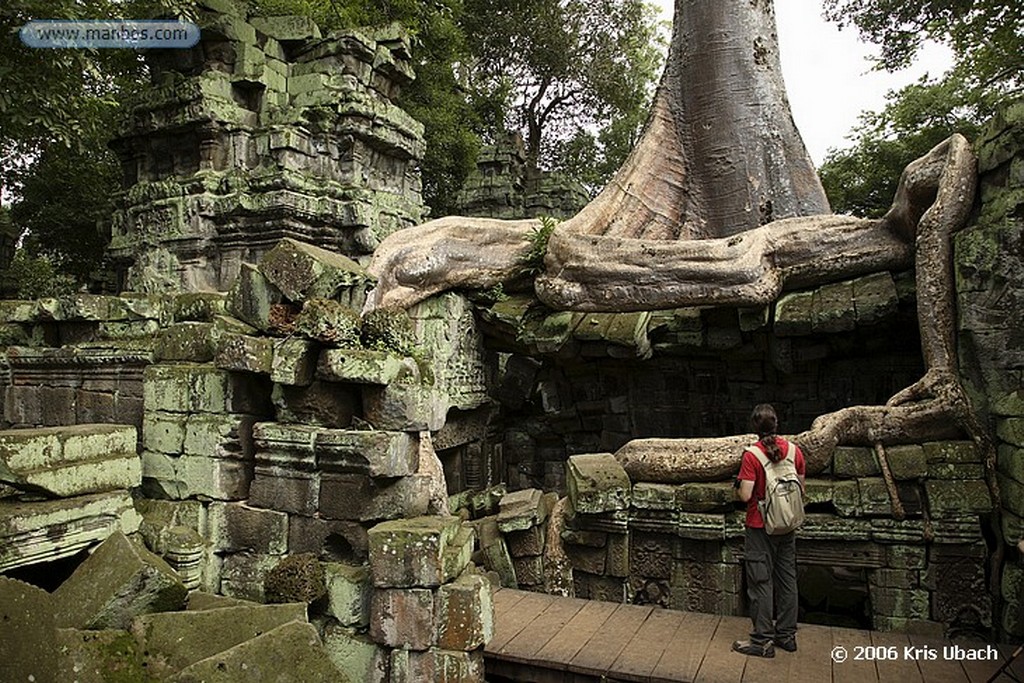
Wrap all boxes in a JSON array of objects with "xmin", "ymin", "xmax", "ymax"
[{"xmin": 955, "ymin": 100, "xmax": 1024, "ymax": 638}]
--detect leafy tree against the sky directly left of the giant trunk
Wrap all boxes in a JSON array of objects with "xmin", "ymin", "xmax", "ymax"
[{"xmin": 463, "ymin": 0, "xmax": 663, "ymax": 175}]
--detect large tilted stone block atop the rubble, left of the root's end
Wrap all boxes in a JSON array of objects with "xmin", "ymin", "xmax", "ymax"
[{"xmin": 258, "ymin": 238, "xmax": 371, "ymax": 301}]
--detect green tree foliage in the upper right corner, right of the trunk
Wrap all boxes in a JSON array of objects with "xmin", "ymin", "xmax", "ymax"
[{"xmin": 820, "ymin": 0, "xmax": 1024, "ymax": 216}]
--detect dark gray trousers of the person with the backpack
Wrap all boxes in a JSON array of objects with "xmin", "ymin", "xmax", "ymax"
[{"xmin": 743, "ymin": 527, "xmax": 798, "ymax": 644}]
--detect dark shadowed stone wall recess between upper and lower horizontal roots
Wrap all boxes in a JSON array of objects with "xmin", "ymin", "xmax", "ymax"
[{"xmin": 481, "ymin": 272, "xmax": 924, "ymax": 488}]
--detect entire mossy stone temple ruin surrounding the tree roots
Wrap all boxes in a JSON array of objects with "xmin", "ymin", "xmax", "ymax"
[{"xmin": 0, "ymin": 3, "xmax": 1024, "ymax": 683}]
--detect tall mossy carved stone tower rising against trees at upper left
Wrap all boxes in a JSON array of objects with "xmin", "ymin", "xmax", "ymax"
[{"xmin": 110, "ymin": 3, "xmax": 424, "ymax": 292}]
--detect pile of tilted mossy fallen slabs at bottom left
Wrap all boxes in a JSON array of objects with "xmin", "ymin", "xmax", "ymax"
[{"xmin": 0, "ymin": 532, "xmax": 348, "ymax": 683}]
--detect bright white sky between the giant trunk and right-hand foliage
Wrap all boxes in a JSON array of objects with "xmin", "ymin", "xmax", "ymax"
[{"xmin": 652, "ymin": 0, "xmax": 951, "ymax": 165}]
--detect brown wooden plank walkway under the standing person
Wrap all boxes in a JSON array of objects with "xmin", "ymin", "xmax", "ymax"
[{"xmin": 484, "ymin": 589, "xmax": 1024, "ymax": 683}]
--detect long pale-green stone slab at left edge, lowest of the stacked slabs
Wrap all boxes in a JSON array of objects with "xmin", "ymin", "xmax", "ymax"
[{"xmin": 0, "ymin": 492, "xmax": 142, "ymax": 571}]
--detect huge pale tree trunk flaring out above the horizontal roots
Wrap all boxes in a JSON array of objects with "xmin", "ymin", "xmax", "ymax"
[{"xmin": 559, "ymin": 0, "xmax": 829, "ymax": 240}]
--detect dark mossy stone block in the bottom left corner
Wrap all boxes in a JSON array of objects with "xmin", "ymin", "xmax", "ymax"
[{"xmin": 0, "ymin": 577, "xmax": 57, "ymax": 683}]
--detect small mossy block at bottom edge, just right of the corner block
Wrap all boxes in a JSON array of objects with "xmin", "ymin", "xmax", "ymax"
[{"xmin": 54, "ymin": 629, "xmax": 151, "ymax": 683}]
